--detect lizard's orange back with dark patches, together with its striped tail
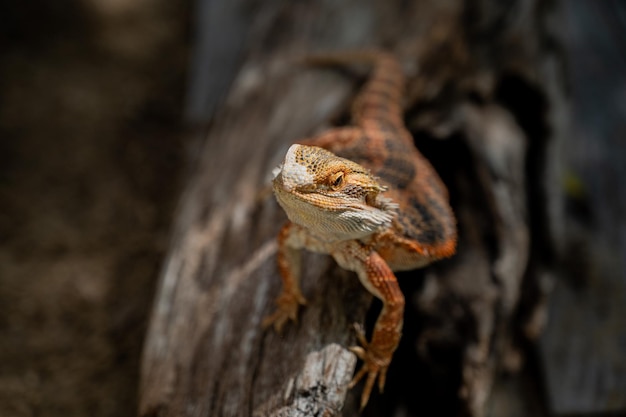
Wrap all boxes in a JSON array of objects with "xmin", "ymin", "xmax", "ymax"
[{"xmin": 308, "ymin": 52, "xmax": 457, "ymax": 258}]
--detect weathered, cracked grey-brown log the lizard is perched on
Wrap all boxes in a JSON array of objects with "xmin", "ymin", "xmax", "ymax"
[{"xmin": 140, "ymin": 0, "xmax": 560, "ymax": 416}]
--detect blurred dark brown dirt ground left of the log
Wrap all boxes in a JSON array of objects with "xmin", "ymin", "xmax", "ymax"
[{"xmin": 0, "ymin": 0, "xmax": 188, "ymax": 417}]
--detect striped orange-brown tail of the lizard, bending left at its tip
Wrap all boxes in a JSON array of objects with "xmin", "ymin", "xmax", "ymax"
[{"xmin": 305, "ymin": 51, "xmax": 405, "ymax": 127}]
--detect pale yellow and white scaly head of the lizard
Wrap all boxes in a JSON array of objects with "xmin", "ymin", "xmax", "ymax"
[{"xmin": 272, "ymin": 144, "xmax": 397, "ymax": 241}]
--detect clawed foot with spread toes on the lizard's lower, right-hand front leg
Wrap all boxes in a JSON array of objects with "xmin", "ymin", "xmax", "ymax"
[{"xmin": 348, "ymin": 324, "xmax": 391, "ymax": 410}]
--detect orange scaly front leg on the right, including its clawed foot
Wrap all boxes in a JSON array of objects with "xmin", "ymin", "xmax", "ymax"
[{"xmin": 332, "ymin": 241, "xmax": 404, "ymax": 409}]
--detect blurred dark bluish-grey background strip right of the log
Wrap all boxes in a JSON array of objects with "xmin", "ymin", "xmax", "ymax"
[{"xmin": 540, "ymin": 0, "xmax": 626, "ymax": 414}]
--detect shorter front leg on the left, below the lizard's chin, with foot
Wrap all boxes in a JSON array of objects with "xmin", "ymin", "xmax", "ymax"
[{"xmin": 263, "ymin": 222, "xmax": 306, "ymax": 332}]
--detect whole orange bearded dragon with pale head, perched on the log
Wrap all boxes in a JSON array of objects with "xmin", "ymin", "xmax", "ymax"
[{"xmin": 264, "ymin": 52, "xmax": 456, "ymax": 408}]
